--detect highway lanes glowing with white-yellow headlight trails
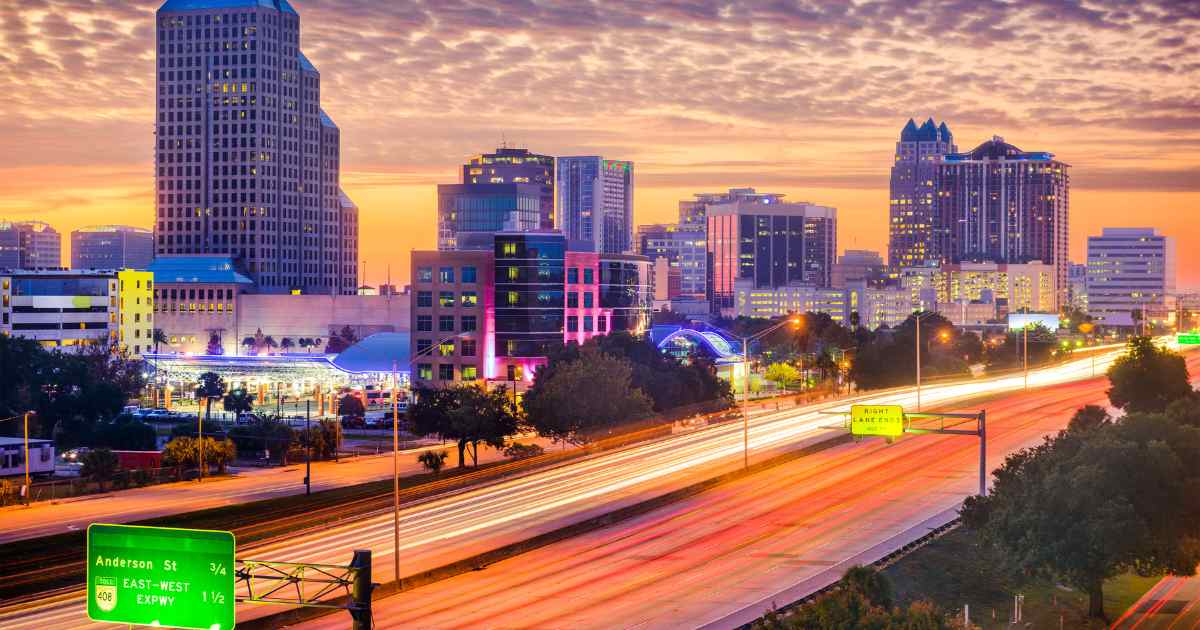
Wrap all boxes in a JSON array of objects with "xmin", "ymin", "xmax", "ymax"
[{"xmin": 0, "ymin": 340, "xmax": 1180, "ymax": 630}]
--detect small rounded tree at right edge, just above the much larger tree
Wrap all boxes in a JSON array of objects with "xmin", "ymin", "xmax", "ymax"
[{"xmin": 1108, "ymin": 337, "xmax": 1192, "ymax": 412}]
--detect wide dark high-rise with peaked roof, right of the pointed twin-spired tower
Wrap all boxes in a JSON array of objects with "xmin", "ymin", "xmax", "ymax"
[{"xmin": 935, "ymin": 136, "xmax": 1070, "ymax": 306}]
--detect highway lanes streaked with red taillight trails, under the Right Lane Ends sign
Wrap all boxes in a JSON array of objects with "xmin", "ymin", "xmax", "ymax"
[{"xmin": 301, "ymin": 372, "xmax": 1142, "ymax": 629}]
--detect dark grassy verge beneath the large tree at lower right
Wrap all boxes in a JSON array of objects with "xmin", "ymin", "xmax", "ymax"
[{"xmin": 883, "ymin": 528, "xmax": 1158, "ymax": 630}]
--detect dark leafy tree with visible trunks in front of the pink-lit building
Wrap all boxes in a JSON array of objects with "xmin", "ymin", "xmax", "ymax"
[{"xmin": 408, "ymin": 385, "xmax": 521, "ymax": 468}]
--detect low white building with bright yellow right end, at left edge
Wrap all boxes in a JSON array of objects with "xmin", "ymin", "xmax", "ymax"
[{"xmin": 0, "ymin": 270, "xmax": 154, "ymax": 356}]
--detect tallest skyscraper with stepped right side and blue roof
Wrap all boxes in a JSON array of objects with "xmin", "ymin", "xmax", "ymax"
[{"xmin": 155, "ymin": 0, "xmax": 359, "ymax": 294}]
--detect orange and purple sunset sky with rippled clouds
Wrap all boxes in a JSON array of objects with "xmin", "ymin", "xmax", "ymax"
[{"xmin": 0, "ymin": 0, "xmax": 1200, "ymax": 287}]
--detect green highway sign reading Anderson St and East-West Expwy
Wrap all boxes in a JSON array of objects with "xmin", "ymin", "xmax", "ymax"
[{"xmin": 88, "ymin": 523, "xmax": 235, "ymax": 630}]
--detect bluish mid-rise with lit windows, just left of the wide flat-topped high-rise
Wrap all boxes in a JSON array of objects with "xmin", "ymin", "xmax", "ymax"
[{"xmin": 637, "ymin": 223, "xmax": 708, "ymax": 300}]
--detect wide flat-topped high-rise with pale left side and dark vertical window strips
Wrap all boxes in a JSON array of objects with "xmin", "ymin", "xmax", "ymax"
[{"xmin": 707, "ymin": 194, "xmax": 838, "ymax": 312}]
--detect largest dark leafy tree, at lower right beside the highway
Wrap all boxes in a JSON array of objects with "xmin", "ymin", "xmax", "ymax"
[{"xmin": 961, "ymin": 409, "xmax": 1200, "ymax": 618}]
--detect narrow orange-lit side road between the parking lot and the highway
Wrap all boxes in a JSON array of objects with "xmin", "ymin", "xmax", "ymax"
[{"xmin": 0, "ymin": 439, "xmax": 545, "ymax": 544}]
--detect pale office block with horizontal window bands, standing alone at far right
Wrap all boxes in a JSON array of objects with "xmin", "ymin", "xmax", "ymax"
[{"xmin": 1087, "ymin": 228, "xmax": 1176, "ymax": 326}]
